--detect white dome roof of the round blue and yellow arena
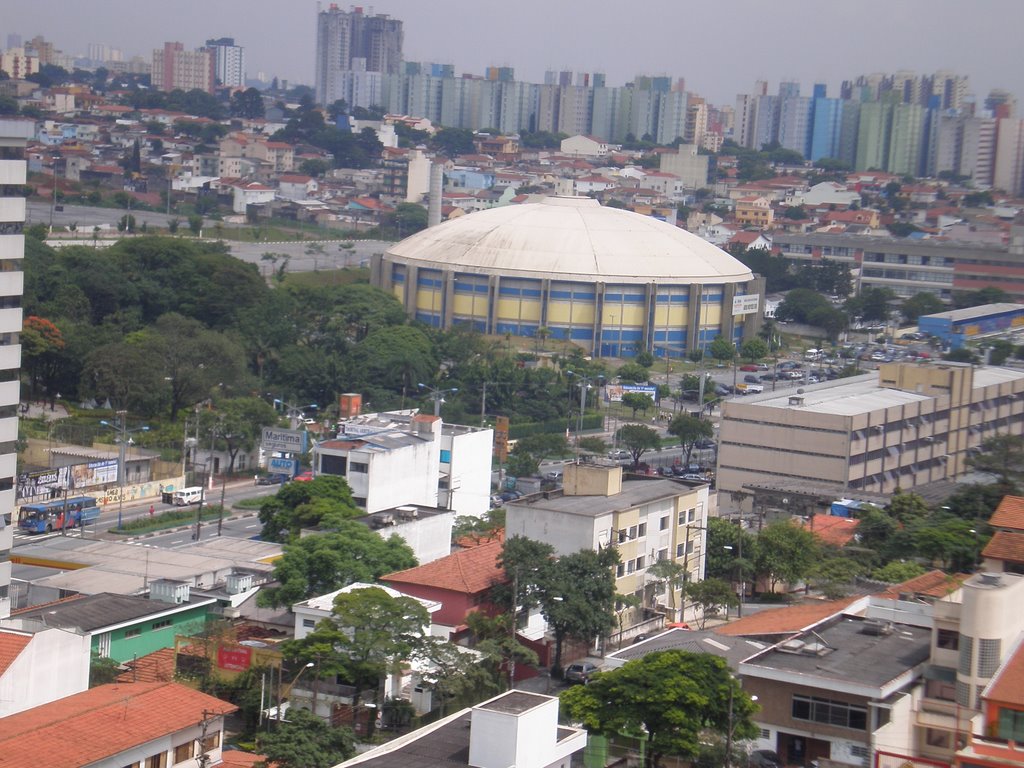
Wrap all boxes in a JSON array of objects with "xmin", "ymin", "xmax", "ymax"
[{"xmin": 388, "ymin": 198, "xmax": 754, "ymax": 284}]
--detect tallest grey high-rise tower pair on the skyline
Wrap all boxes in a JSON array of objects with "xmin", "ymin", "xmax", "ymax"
[{"xmin": 316, "ymin": 3, "xmax": 403, "ymax": 105}]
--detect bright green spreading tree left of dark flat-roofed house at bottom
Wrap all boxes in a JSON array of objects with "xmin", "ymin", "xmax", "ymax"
[{"xmin": 560, "ymin": 650, "xmax": 757, "ymax": 768}]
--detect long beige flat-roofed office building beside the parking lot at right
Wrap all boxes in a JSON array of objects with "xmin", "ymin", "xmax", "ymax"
[{"xmin": 718, "ymin": 362, "xmax": 1024, "ymax": 506}]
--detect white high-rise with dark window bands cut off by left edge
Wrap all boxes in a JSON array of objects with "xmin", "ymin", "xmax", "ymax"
[{"xmin": 0, "ymin": 120, "xmax": 30, "ymax": 618}]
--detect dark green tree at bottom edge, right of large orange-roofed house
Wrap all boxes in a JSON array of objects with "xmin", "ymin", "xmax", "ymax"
[{"xmin": 257, "ymin": 696, "xmax": 355, "ymax": 768}]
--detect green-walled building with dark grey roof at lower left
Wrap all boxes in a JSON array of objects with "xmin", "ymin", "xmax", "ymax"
[{"xmin": 12, "ymin": 580, "xmax": 217, "ymax": 663}]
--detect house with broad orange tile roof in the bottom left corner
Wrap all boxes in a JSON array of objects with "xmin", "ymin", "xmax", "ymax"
[{"xmin": 0, "ymin": 683, "xmax": 238, "ymax": 768}]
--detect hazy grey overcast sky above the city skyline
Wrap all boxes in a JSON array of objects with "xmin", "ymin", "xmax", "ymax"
[{"xmin": 0, "ymin": 0, "xmax": 1024, "ymax": 103}]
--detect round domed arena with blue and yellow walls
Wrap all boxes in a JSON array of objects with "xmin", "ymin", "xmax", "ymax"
[{"xmin": 372, "ymin": 197, "xmax": 764, "ymax": 357}]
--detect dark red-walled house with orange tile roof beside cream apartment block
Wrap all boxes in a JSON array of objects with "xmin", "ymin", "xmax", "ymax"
[{"xmin": 381, "ymin": 540, "xmax": 508, "ymax": 640}]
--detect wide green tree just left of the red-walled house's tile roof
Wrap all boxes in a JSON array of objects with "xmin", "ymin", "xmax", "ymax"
[{"xmin": 260, "ymin": 528, "xmax": 416, "ymax": 606}]
